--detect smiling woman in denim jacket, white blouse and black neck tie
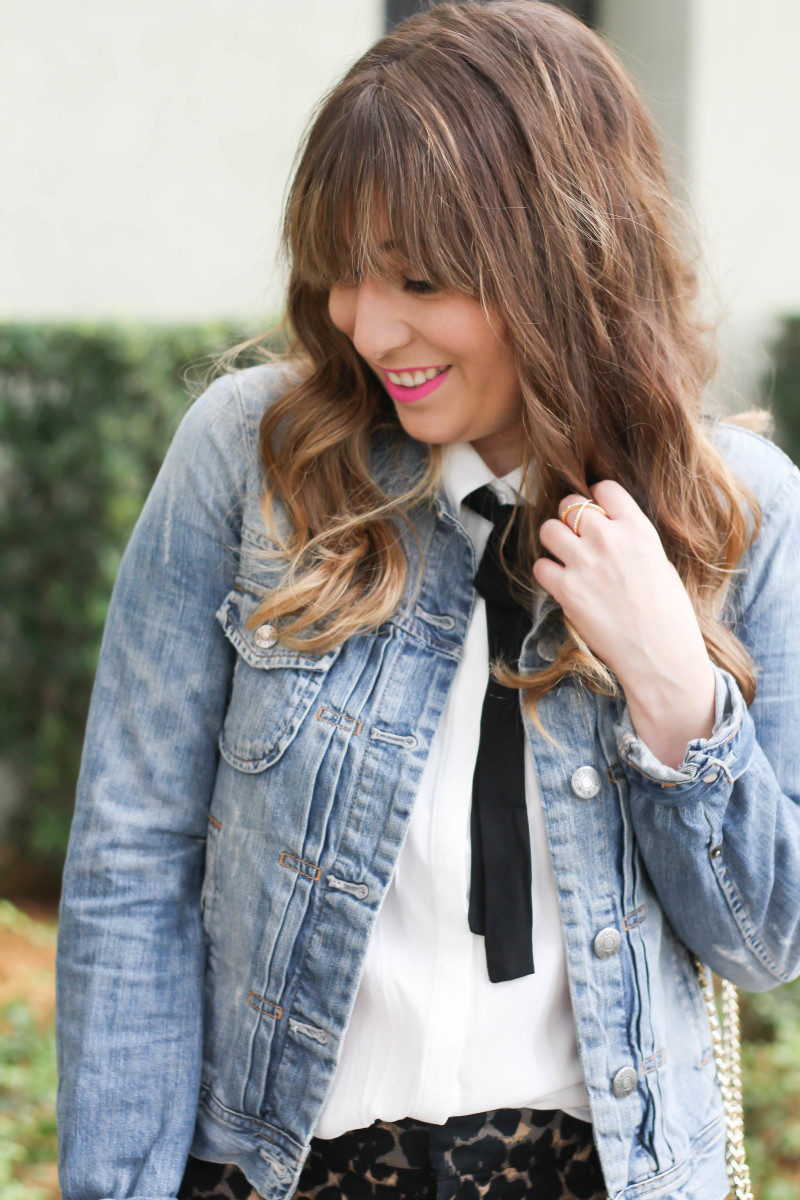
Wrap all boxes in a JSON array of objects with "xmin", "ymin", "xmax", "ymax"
[{"xmin": 58, "ymin": 0, "xmax": 800, "ymax": 1200}]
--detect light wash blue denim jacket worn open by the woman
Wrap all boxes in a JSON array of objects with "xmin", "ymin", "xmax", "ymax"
[{"xmin": 58, "ymin": 366, "xmax": 800, "ymax": 1200}]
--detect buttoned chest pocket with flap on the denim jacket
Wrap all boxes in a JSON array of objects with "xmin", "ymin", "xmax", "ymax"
[{"xmin": 216, "ymin": 588, "xmax": 342, "ymax": 774}]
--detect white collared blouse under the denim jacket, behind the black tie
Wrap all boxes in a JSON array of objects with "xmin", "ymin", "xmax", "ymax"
[{"xmin": 314, "ymin": 442, "xmax": 591, "ymax": 1138}]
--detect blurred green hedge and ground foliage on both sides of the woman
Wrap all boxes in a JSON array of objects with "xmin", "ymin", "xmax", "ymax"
[{"xmin": 0, "ymin": 317, "xmax": 800, "ymax": 1200}]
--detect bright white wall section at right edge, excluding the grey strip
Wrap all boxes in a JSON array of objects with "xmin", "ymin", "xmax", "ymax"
[{"xmin": 690, "ymin": 0, "xmax": 800, "ymax": 405}]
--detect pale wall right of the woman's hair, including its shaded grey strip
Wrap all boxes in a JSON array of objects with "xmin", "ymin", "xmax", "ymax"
[{"xmin": 601, "ymin": 0, "xmax": 800, "ymax": 403}]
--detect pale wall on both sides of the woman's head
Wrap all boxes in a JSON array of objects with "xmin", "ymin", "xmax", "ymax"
[{"xmin": 6, "ymin": 0, "xmax": 800, "ymax": 408}]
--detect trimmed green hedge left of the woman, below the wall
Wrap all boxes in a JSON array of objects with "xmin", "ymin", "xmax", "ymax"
[{"xmin": 0, "ymin": 324, "xmax": 281, "ymax": 877}]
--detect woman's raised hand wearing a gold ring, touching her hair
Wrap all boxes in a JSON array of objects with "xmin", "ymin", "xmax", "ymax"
[{"xmin": 534, "ymin": 479, "xmax": 714, "ymax": 763}]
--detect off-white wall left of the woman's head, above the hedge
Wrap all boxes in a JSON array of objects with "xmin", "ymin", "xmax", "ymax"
[{"xmin": 0, "ymin": 0, "xmax": 383, "ymax": 319}]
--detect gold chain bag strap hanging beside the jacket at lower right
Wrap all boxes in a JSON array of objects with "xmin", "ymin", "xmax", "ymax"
[{"xmin": 694, "ymin": 956, "xmax": 753, "ymax": 1200}]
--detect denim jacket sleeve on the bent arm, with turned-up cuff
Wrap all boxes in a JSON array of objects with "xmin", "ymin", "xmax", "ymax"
[{"xmin": 614, "ymin": 451, "xmax": 800, "ymax": 991}]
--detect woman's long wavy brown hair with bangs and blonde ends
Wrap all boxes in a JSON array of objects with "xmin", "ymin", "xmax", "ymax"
[{"xmin": 212, "ymin": 0, "xmax": 771, "ymax": 740}]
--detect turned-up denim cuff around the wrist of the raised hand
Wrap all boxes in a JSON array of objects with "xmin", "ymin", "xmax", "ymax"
[{"xmin": 614, "ymin": 662, "xmax": 756, "ymax": 799}]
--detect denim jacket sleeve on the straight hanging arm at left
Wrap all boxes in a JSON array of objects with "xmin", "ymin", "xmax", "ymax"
[{"xmin": 56, "ymin": 377, "xmax": 246, "ymax": 1200}]
